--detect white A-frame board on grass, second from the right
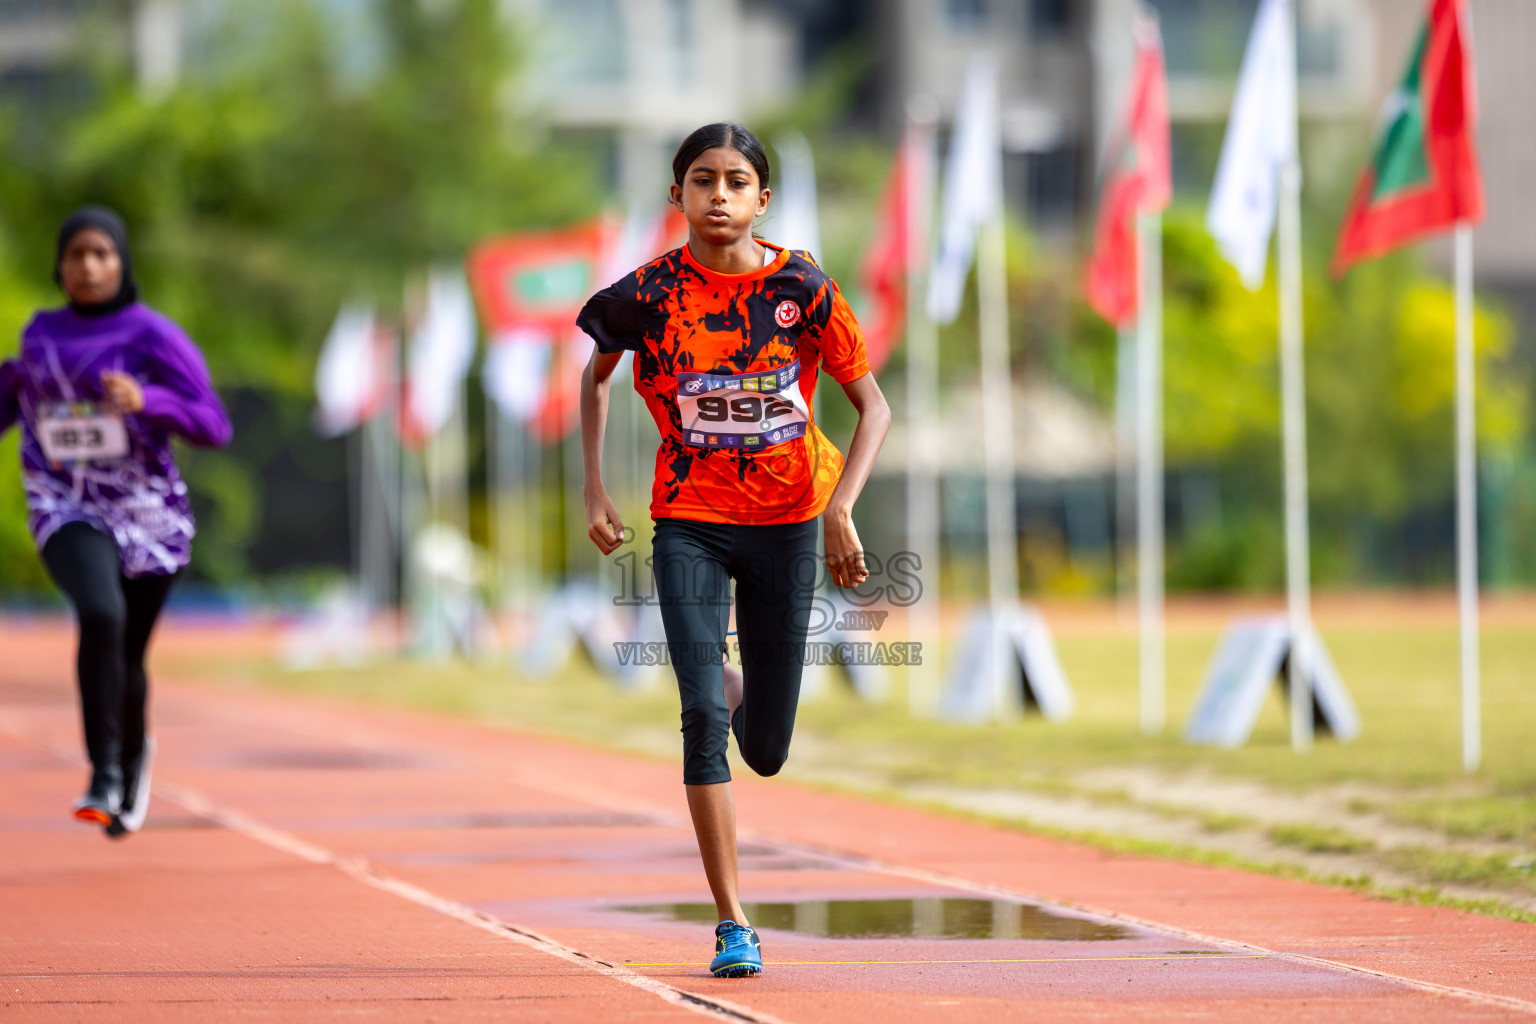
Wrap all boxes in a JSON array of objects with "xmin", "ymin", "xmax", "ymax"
[{"xmin": 938, "ymin": 605, "xmax": 1074, "ymax": 722}]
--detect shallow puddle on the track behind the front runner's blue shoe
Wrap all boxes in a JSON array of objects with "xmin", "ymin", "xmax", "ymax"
[{"xmin": 616, "ymin": 898, "xmax": 1135, "ymax": 943}]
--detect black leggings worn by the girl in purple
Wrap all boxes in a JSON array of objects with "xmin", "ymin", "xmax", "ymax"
[{"xmin": 43, "ymin": 522, "xmax": 175, "ymax": 774}]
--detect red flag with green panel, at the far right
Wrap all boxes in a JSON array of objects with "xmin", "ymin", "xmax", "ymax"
[{"xmin": 1333, "ymin": 0, "xmax": 1484, "ymax": 278}]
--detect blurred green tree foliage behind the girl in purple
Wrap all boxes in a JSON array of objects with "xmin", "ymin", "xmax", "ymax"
[{"xmin": 0, "ymin": 0, "xmax": 598, "ymax": 586}]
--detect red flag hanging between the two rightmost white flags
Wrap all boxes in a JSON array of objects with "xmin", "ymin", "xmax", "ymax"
[{"xmin": 1087, "ymin": 18, "xmax": 1174, "ymax": 325}]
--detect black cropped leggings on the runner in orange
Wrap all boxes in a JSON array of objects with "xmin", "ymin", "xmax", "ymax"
[{"xmin": 653, "ymin": 519, "xmax": 820, "ymax": 786}]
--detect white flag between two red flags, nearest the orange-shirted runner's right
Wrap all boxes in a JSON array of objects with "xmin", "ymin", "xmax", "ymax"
[{"xmin": 928, "ymin": 57, "xmax": 1003, "ymax": 324}]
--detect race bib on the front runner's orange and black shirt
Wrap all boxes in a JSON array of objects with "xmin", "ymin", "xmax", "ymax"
[{"xmin": 677, "ymin": 359, "xmax": 811, "ymax": 451}]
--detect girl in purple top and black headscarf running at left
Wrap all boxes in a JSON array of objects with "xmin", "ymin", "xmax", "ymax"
[{"xmin": 0, "ymin": 206, "xmax": 229, "ymax": 837}]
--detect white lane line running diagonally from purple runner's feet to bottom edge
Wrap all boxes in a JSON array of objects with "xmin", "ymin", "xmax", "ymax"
[{"xmin": 157, "ymin": 783, "xmax": 790, "ymax": 1024}]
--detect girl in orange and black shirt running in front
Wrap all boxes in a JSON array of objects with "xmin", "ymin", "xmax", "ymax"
[{"xmin": 576, "ymin": 123, "xmax": 891, "ymax": 978}]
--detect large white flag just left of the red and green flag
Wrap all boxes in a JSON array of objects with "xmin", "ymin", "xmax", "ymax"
[{"xmin": 1206, "ymin": 0, "xmax": 1296, "ymax": 290}]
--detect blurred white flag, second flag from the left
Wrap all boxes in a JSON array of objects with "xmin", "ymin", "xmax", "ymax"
[{"xmin": 407, "ymin": 270, "xmax": 475, "ymax": 438}]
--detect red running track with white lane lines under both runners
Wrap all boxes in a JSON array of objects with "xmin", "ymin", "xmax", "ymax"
[{"xmin": 0, "ymin": 623, "xmax": 1536, "ymax": 1024}]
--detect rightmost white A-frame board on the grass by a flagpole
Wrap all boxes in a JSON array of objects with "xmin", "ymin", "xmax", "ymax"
[{"xmin": 1184, "ymin": 616, "xmax": 1359, "ymax": 746}]
